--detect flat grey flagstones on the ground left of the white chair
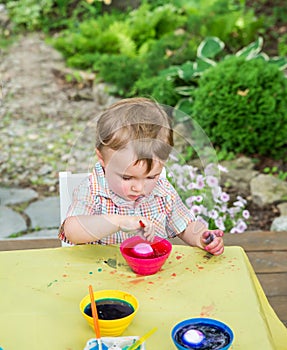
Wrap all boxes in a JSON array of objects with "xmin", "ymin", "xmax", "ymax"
[{"xmin": 0, "ymin": 187, "xmax": 60, "ymax": 239}]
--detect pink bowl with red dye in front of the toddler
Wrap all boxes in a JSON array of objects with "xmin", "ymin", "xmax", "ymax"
[{"xmin": 120, "ymin": 236, "xmax": 172, "ymax": 275}]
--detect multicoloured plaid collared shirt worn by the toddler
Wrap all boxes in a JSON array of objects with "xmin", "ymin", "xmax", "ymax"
[{"xmin": 59, "ymin": 163, "xmax": 194, "ymax": 244}]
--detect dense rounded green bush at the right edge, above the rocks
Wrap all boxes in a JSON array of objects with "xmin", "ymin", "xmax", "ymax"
[{"xmin": 192, "ymin": 56, "xmax": 287, "ymax": 157}]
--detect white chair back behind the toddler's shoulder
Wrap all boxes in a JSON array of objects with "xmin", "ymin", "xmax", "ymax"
[{"xmin": 59, "ymin": 171, "xmax": 89, "ymax": 247}]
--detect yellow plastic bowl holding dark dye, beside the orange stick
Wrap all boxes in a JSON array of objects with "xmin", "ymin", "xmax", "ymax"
[{"xmin": 80, "ymin": 290, "xmax": 139, "ymax": 337}]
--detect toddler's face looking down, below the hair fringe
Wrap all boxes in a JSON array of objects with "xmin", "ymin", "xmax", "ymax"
[{"xmin": 97, "ymin": 149, "xmax": 164, "ymax": 201}]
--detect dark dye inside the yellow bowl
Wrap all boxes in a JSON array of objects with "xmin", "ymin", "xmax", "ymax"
[{"xmin": 84, "ymin": 298, "xmax": 134, "ymax": 320}]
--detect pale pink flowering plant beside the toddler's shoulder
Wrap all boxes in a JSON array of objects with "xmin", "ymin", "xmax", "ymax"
[{"xmin": 167, "ymin": 164, "xmax": 250, "ymax": 233}]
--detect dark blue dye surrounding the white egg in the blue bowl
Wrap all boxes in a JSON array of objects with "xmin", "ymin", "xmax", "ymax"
[{"xmin": 175, "ymin": 323, "xmax": 230, "ymax": 350}]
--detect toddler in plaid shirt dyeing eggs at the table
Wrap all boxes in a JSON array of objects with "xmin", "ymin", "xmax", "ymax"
[{"xmin": 59, "ymin": 98, "xmax": 224, "ymax": 255}]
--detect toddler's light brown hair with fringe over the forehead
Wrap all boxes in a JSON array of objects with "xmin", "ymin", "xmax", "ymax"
[{"xmin": 96, "ymin": 98, "xmax": 173, "ymax": 172}]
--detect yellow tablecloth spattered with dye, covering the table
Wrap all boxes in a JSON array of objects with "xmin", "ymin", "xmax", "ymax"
[{"xmin": 0, "ymin": 245, "xmax": 287, "ymax": 350}]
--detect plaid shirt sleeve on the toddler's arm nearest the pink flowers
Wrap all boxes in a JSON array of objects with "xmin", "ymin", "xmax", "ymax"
[{"xmin": 165, "ymin": 180, "xmax": 194, "ymax": 237}]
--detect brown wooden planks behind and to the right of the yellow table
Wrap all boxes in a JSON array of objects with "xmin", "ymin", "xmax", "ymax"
[{"xmin": 0, "ymin": 231, "xmax": 287, "ymax": 326}]
